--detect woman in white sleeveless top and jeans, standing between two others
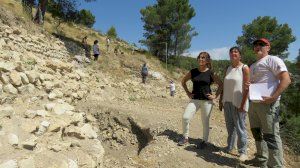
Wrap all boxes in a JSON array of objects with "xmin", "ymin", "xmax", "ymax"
[{"xmin": 219, "ymin": 47, "xmax": 250, "ymax": 162}]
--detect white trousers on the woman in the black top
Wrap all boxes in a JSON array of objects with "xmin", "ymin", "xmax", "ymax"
[{"xmin": 182, "ymin": 99, "xmax": 213, "ymax": 142}]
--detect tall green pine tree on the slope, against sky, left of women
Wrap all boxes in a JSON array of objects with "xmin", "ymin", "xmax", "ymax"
[{"xmin": 140, "ymin": 0, "xmax": 197, "ymax": 59}]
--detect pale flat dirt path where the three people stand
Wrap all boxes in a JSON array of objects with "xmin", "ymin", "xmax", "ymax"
[{"xmin": 78, "ymin": 94, "xmax": 260, "ymax": 167}]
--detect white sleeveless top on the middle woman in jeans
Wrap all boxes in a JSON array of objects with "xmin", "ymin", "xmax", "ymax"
[{"xmin": 223, "ymin": 64, "xmax": 249, "ymax": 111}]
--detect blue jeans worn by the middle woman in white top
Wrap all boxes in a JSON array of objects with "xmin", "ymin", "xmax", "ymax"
[{"xmin": 224, "ymin": 102, "xmax": 248, "ymax": 154}]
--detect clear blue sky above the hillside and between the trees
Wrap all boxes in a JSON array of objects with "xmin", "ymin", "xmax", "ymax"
[{"xmin": 79, "ymin": 0, "xmax": 300, "ymax": 60}]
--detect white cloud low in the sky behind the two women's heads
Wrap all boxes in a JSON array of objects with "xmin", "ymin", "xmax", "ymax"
[{"xmin": 184, "ymin": 47, "xmax": 230, "ymax": 60}]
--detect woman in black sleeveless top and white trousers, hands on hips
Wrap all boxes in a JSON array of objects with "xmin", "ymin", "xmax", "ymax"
[{"xmin": 178, "ymin": 52, "xmax": 222, "ymax": 149}]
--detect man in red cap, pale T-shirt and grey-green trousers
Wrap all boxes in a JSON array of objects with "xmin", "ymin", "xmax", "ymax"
[{"xmin": 248, "ymin": 38, "xmax": 291, "ymax": 167}]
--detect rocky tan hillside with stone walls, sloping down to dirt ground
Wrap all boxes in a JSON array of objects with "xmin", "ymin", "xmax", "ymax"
[{"xmin": 0, "ymin": 1, "xmax": 297, "ymax": 168}]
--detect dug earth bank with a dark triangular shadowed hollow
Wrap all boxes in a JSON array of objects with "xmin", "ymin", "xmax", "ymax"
[{"xmin": 94, "ymin": 109, "xmax": 153, "ymax": 155}]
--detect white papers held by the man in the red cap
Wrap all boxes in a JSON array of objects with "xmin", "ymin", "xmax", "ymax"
[{"xmin": 249, "ymin": 83, "xmax": 278, "ymax": 101}]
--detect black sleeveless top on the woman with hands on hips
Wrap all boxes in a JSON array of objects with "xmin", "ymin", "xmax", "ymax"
[{"xmin": 190, "ymin": 68, "xmax": 214, "ymax": 100}]
